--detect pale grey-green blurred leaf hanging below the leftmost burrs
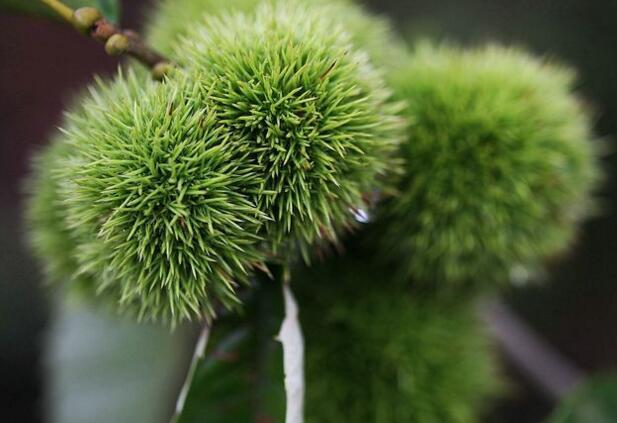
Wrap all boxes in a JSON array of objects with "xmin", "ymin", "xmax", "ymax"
[{"xmin": 46, "ymin": 298, "xmax": 190, "ymax": 423}]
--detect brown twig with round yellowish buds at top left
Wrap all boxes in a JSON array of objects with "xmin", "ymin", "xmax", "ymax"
[{"xmin": 41, "ymin": 0, "xmax": 174, "ymax": 80}]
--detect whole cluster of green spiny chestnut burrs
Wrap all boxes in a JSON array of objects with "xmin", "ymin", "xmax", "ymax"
[{"xmin": 29, "ymin": 0, "xmax": 600, "ymax": 422}]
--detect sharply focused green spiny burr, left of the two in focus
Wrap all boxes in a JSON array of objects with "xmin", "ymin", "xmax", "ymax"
[{"xmin": 50, "ymin": 73, "xmax": 264, "ymax": 323}]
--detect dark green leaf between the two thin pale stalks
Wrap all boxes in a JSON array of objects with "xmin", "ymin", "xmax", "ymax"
[{"xmin": 179, "ymin": 281, "xmax": 285, "ymax": 423}]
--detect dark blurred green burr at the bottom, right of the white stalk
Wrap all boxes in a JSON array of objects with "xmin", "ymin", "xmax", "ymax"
[{"xmin": 292, "ymin": 240, "xmax": 501, "ymax": 423}]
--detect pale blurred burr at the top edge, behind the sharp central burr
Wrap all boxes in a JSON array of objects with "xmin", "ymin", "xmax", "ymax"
[{"xmin": 146, "ymin": 0, "xmax": 407, "ymax": 66}]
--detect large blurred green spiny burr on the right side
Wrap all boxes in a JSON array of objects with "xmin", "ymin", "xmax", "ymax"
[{"xmin": 376, "ymin": 45, "xmax": 599, "ymax": 287}]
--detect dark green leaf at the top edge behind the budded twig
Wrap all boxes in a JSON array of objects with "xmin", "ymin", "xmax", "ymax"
[{"xmin": 0, "ymin": 0, "xmax": 120, "ymax": 23}]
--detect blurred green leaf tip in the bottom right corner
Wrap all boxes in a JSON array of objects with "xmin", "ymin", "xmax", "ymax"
[{"xmin": 548, "ymin": 375, "xmax": 617, "ymax": 423}]
